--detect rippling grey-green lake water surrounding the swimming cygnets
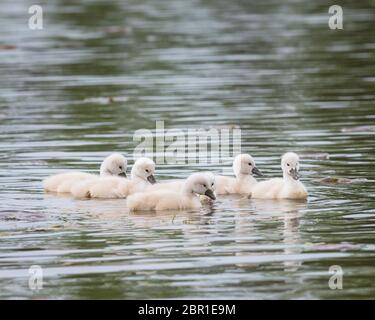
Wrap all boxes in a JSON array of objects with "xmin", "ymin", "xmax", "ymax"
[{"xmin": 0, "ymin": 0, "xmax": 375, "ymax": 299}]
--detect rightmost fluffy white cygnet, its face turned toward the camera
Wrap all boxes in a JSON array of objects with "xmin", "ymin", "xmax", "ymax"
[{"xmin": 251, "ymin": 152, "xmax": 308, "ymax": 199}]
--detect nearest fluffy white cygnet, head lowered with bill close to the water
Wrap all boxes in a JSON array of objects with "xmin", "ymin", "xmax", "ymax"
[{"xmin": 127, "ymin": 173, "xmax": 216, "ymax": 211}]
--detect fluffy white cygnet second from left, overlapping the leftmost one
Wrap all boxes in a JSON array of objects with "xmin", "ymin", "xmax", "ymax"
[{"xmin": 71, "ymin": 158, "xmax": 155, "ymax": 199}]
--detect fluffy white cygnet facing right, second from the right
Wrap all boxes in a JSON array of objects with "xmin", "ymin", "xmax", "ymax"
[{"xmin": 215, "ymin": 154, "xmax": 263, "ymax": 194}]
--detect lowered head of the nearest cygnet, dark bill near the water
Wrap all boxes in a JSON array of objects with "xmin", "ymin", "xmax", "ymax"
[{"xmin": 185, "ymin": 172, "xmax": 216, "ymax": 200}]
